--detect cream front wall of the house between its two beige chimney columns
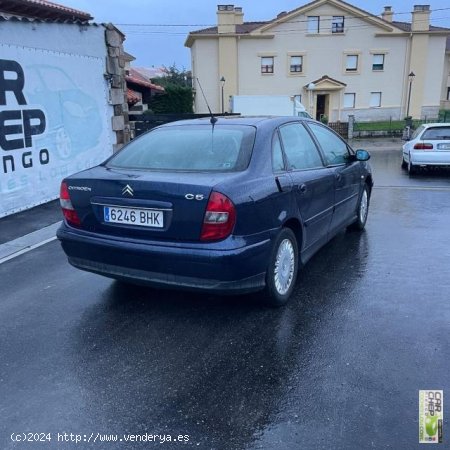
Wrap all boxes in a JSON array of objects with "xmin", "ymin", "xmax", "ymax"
[{"xmin": 238, "ymin": 6, "xmax": 407, "ymax": 119}]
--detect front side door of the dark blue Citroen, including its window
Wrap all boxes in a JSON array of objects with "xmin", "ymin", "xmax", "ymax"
[{"xmin": 308, "ymin": 122, "xmax": 362, "ymax": 231}]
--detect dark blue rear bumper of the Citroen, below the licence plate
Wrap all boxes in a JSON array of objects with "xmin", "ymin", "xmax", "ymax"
[{"xmin": 57, "ymin": 224, "xmax": 271, "ymax": 294}]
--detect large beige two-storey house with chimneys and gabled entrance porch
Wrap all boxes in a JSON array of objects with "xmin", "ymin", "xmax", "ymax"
[{"xmin": 185, "ymin": 0, "xmax": 450, "ymax": 121}]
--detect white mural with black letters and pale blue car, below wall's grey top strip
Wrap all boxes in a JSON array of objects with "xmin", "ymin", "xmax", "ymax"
[{"xmin": 0, "ymin": 44, "xmax": 112, "ymax": 217}]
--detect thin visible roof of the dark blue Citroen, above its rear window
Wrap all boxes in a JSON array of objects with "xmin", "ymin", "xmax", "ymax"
[{"xmin": 161, "ymin": 116, "xmax": 314, "ymax": 127}]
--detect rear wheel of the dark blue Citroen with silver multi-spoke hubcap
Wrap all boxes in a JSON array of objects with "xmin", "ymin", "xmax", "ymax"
[{"xmin": 264, "ymin": 228, "xmax": 298, "ymax": 307}]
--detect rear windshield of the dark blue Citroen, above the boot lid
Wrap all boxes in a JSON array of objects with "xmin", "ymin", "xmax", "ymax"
[{"xmin": 106, "ymin": 124, "xmax": 255, "ymax": 172}]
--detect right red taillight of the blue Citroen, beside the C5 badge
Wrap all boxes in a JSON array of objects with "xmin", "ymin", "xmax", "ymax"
[{"xmin": 200, "ymin": 192, "xmax": 236, "ymax": 241}]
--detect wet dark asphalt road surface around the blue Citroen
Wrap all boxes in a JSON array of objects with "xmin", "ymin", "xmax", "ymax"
[{"xmin": 0, "ymin": 150, "xmax": 450, "ymax": 450}]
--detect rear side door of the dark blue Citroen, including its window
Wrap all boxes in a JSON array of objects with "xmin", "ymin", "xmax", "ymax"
[{"xmin": 279, "ymin": 122, "xmax": 334, "ymax": 250}]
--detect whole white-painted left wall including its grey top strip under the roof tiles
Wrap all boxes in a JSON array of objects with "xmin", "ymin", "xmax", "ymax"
[{"xmin": 0, "ymin": 21, "xmax": 116, "ymax": 217}]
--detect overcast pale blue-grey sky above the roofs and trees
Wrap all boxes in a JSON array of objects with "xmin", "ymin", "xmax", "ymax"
[{"xmin": 65, "ymin": 0, "xmax": 450, "ymax": 69}]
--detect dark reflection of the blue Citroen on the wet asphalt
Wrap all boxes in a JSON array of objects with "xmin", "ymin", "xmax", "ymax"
[{"xmin": 73, "ymin": 233, "xmax": 369, "ymax": 448}]
